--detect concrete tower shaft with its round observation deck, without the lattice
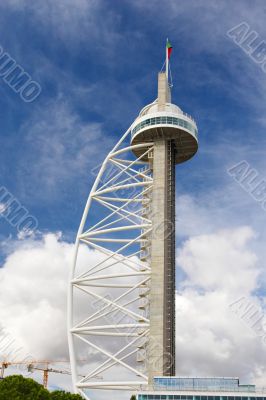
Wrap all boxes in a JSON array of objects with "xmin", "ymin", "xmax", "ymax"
[{"xmin": 131, "ymin": 73, "xmax": 198, "ymax": 384}]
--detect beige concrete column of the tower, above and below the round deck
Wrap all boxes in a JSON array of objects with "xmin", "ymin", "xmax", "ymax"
[{"xmin": 147, "ymin": 73, "xmax": 175, "ymax": 384}]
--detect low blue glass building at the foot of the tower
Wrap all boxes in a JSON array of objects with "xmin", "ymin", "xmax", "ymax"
[{"xmin": 137, "ymin": 377, "xmax": 266, "ymax": 400}]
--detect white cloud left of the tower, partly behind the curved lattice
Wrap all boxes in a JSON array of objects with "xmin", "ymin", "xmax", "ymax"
[{"xmin": 0, "ymin": 233, "xmax": 141, "ymax": 399}]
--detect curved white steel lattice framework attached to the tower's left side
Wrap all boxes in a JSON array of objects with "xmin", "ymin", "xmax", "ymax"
[{"xmin": 68, "ymin": 124, "xmax": 153, "ymax": 399}]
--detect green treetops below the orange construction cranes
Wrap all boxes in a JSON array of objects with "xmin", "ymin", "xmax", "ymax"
[{"xmin": 0, "ymin": 375, "xmax": 83, "ymax": 400}]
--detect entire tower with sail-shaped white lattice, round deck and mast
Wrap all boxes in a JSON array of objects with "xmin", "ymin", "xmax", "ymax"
[{"xmin": 68, "ymin": 46, "xmax": 198, "ymax": 399}]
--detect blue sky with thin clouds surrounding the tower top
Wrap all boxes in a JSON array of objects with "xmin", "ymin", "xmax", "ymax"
[{"xmin": 0, "ymin": 0, "xmax": 266, "ymax": 394}]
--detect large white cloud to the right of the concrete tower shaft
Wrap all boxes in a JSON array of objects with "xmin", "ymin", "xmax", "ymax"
[{"xmin": 176, "ymin": 227, "xmax": 266, "ymax": 384}]
